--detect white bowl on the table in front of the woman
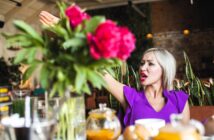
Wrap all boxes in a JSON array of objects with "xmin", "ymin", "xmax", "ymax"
[{"xmin": 135, "ymin": 118, "xmax": 166, "ymax": 137}]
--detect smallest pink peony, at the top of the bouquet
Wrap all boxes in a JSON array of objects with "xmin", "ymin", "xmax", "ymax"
[{"xmin": 65, "ymin": 5, "xmax": 90, "ymax": 28}]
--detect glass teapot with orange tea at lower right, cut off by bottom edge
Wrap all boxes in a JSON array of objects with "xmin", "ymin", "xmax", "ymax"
[{"xmin": 153, "ymin": 114, "xmax": 205, "ymax": 140}]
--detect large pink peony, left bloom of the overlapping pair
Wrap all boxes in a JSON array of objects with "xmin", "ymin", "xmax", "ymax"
[{"xmin": 87, "ymin": 20, "xmax": 120, "ymax": 59}]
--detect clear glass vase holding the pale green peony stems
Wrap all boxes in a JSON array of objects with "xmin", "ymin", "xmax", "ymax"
[{"xmin": 57, "ymin": 94, "xmax": 86, "ymax": 140}]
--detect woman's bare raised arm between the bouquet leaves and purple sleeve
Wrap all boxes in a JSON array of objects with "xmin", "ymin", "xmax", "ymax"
[{"xmin": 103, "ymin": 73, "xmax": 127, "ymax": 110}]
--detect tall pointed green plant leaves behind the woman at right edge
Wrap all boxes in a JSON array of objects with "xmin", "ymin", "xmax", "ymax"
[{"xmin": 175, "ymin": 52, "xmax": 214, "ymax": 106}]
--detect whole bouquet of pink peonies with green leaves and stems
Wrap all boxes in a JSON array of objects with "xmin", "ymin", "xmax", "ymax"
[{"xmin": 4, "ymin": 3, "xmax": 135, "ymax": 140}]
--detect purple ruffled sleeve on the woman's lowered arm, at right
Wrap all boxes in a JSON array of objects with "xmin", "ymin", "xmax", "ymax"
[{"xmin": 174, "ymin": 91, "xmax": 189, "ymax": 113}]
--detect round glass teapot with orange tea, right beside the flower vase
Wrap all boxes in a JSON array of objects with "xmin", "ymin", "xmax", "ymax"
[{"xmin": 86, "ymin": 104, "xmax": 121, "ymax": 140}]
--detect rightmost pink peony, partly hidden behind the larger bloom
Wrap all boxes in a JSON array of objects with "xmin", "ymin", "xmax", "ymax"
[{"xmin": 117, "ymin": 27, "xmax": 136, "ymax": 60}]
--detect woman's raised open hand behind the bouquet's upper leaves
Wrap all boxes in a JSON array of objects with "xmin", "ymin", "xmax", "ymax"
[{"xmin": 39, "ymin": 11, "xmax": 59, "ymax": 26}]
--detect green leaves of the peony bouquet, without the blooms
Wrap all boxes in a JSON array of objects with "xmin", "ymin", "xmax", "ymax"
[{"xmin": 4, "ymin": 4, "xmax": 121, "ymax": 95}]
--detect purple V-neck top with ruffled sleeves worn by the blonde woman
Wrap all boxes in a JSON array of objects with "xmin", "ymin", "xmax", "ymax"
[{"xmin": 123, "ymin": 86, "xmax": 188, "ymax": 126}]
